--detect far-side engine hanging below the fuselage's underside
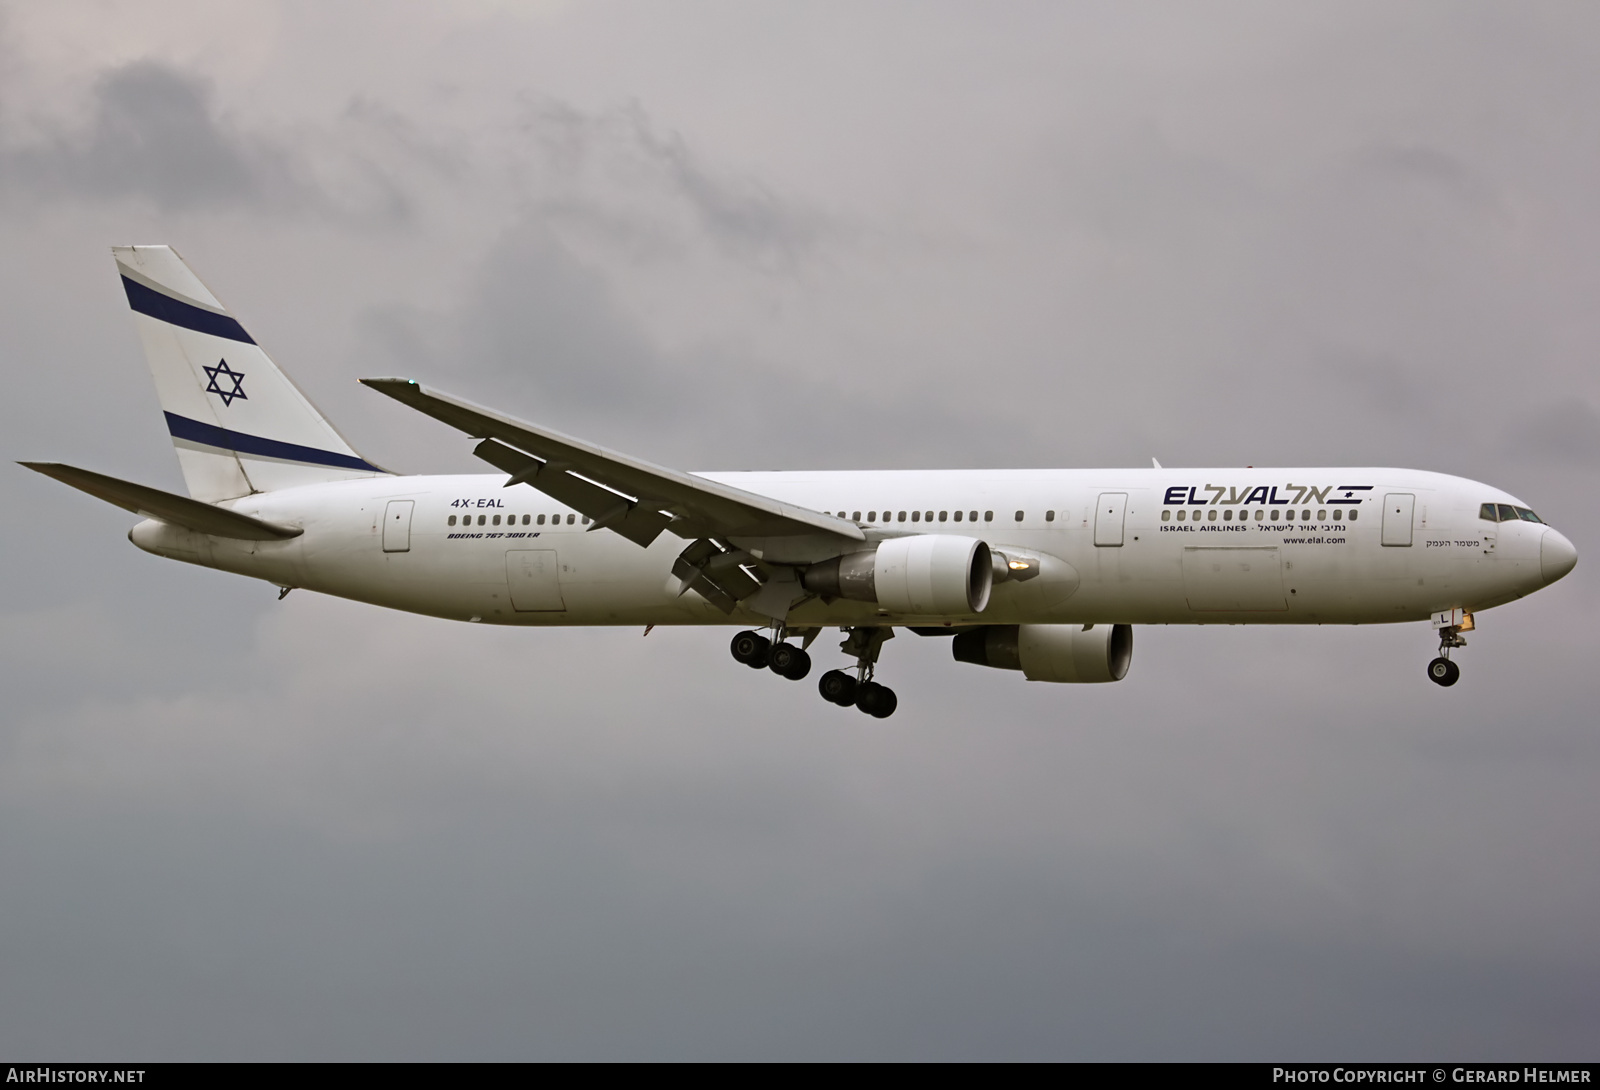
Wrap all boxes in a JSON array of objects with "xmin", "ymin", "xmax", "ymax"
[{"xmin": 950, "ymin": 624, "xmax": 1133, "ymax": 683}]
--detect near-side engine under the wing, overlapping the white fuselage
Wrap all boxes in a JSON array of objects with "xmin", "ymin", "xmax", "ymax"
[{"xmin": 800, "ymin": 533, "xmax": 994, "ymax": 615}]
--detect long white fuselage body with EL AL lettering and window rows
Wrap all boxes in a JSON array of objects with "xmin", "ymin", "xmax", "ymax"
[{"xmin": 130, "ymin": 469, "xmax": 1570, "ymax": 626}]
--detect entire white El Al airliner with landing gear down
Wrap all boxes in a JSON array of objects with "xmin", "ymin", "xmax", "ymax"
[{"xmin": 21, "ymin": 245, "xmax": 1578, "ymax": 719}]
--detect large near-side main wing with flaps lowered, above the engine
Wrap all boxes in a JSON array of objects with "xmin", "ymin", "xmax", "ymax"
[{"xmin": 362, "ymin": 378, "xmax": 866, "ymax": 546}]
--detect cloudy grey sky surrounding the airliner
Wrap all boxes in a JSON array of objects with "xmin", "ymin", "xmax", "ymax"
[{"xmin": 0, "ymin": 0, "xmax": 1600, "ymax": 1060}]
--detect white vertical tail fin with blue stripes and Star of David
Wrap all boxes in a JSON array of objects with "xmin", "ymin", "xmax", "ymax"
[{"xmin": 112, "ymin": 246, "xmax": 386, "ymax": 503}]
